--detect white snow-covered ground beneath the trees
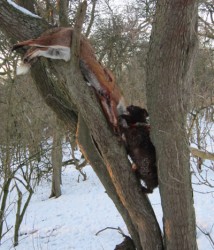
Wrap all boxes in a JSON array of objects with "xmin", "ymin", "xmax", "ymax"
[{"xmin": 0, "ymin": 153, "xmax": 214, "ymax": 250}]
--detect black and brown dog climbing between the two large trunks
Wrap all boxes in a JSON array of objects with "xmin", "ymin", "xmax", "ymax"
[{"xmin": 120, "ymin": 105, "xmax": 158, "ymax": 193}]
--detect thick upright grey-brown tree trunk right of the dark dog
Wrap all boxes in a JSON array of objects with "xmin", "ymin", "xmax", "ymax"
[{"xmin": 147, "ymin": 0, "xmax": 197, "ymax": 250}]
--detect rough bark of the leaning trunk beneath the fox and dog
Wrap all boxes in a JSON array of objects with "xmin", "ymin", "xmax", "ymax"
[{"xmin": 0, "ymin": 0, "xmax": 163, "ymax": 250}]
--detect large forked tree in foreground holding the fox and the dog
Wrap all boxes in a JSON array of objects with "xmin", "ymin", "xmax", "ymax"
[{"xmin": 0, "ymin": 0, "xmax": 201, "ymax": 250}]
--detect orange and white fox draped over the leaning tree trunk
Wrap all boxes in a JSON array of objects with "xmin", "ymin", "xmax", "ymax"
[{"xmin": 12, "ymin": 27, "xmax": 126, "ymax": 130}]
